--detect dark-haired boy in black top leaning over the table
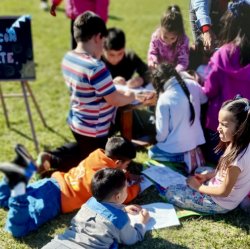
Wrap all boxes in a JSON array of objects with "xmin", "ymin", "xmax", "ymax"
[{"xmin": 102, "ymin": 28, "xmax": 150, "ymax": 88}]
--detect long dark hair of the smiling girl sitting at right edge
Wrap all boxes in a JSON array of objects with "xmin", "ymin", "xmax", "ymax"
[{"xmin": 216, "ymin": 98, "xmax": 250, "ymax": 173}]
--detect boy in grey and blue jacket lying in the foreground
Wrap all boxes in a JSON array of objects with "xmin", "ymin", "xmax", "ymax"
[{"xmin": 43, "ymin": 168, "xmax": 149, "ymax": 249}]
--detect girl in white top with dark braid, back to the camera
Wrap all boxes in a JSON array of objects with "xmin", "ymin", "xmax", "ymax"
[{"xmin": 148, "ymin": 64, "xmax": 207, "ymax": 173}]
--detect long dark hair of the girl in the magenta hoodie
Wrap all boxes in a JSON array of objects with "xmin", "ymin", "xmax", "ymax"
[{"xmin": 219, "ymin": 0, "xmax": 250, "ymax": 66}]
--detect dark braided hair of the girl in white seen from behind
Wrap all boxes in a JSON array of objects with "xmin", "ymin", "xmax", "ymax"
[{"xmin": 152, "ymin": 63, "xmax": 195, "ymax": 125}]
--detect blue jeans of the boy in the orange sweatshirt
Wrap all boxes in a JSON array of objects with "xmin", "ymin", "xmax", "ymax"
[{"xmin": 0, "ymin": 178, "xmax": 61, "ymax": 237}]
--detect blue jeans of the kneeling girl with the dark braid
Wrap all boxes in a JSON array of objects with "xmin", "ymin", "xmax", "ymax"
[{"xmin": 148, "ymin": 145, "xmax": 184, "ymax": 163}]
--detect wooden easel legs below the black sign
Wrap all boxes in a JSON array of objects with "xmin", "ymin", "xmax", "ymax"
[{"xmin": 0, "ymin": 81, "xmax": 48, "ymax": 153}]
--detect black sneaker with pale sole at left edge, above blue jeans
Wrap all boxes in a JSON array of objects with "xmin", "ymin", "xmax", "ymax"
[{"xmin": 0, "ymin": 162, "xmax": 28, "ymax": 189}]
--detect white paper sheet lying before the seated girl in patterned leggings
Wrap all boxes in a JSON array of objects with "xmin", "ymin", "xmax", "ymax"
[{"xmin": 142, "ymin": 161, "xmax": 186, "ymax": 188}]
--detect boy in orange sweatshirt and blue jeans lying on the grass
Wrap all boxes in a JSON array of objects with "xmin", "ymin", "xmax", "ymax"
[{"xmin": 0, "ymin": 137, "xmax": 140, "ymax": 237}]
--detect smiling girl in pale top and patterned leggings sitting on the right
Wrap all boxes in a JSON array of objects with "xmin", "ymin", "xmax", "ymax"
[{"xmin": 166, "ymin": 98, "xmax": 250, "ymax": 213}]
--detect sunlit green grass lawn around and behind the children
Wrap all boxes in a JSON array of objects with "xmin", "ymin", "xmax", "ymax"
[{"xmin": 0, "ymin": 0, "xmax": 250, "ymax": 249}]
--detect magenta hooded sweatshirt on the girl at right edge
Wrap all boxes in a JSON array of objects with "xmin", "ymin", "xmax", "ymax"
[{"xmin": 203, "ymin": 43, "xmax": 250, "ymax": 131}]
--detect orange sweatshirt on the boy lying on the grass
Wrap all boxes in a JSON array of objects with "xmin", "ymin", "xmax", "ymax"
[{"xmin": 52, "ymin": 149, "xmax": 140, "ymax": 213}]
